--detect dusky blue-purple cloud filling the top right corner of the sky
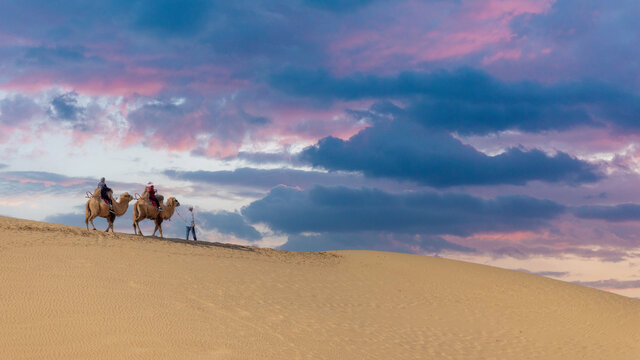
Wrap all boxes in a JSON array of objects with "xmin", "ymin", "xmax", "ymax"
[{"xmin": 510, "ymin": 0, "xmax": 640, "ymax": 89}]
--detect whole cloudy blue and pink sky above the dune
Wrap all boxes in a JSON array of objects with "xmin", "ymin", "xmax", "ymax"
[{"xmin": 0, "ymin": 0, "xmax": 640, "ymax": 297}]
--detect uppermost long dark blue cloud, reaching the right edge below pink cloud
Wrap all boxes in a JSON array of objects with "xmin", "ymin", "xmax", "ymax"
[{"xmin": 270, "ymin": 68, "xmax": 640, "ymax": 134}]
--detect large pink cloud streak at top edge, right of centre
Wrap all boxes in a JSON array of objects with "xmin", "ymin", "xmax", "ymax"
[{"xmin": 329, "ymin": 0, "xmax": 553, "ymax": 73}]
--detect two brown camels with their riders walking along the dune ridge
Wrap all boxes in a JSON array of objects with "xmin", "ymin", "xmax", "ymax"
[{"xmin": 84, "ymin": 178, "xmax": 180, "ymax": 237}]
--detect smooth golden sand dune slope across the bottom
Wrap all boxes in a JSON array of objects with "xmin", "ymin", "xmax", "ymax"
[{"xmin": 0, "ymin": 217, "xmax": 640, "ymax": 360}]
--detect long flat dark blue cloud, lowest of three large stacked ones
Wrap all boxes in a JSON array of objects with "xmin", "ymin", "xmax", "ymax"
[{"xmin": 242, "ymin": 186, "xmax": 565, "ymax": 236}]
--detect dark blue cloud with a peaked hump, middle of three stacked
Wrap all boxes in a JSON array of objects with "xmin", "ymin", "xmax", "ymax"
[{"xmin": 300, "ymin": 120, "xmax": 601, "ymax": 187}]
